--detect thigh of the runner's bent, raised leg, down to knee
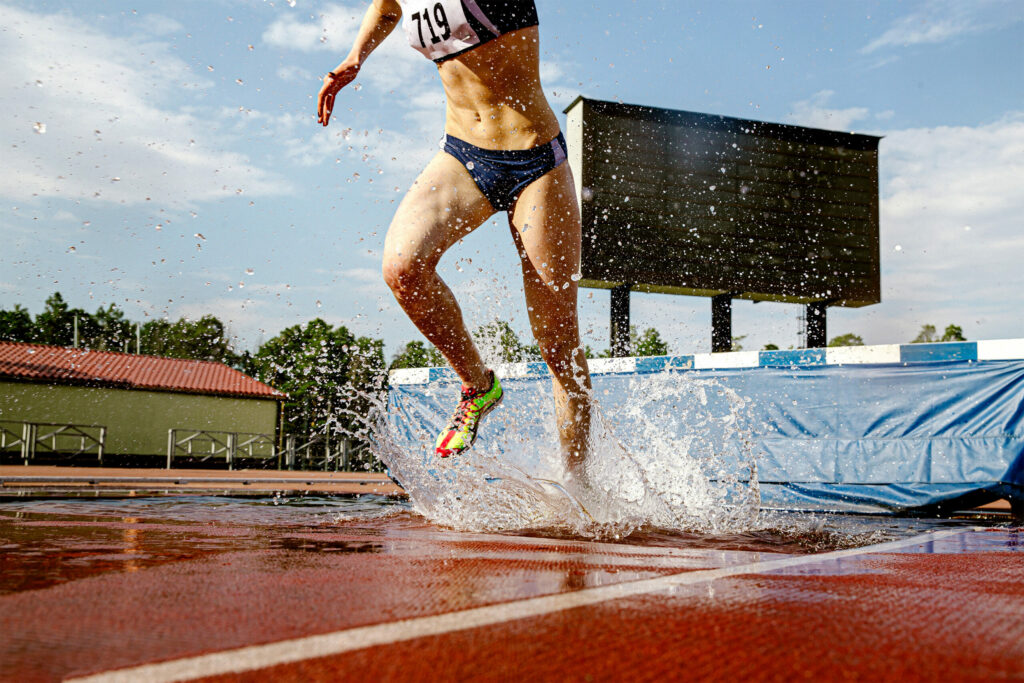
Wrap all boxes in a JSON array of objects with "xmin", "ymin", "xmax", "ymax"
[{"xmin": 384, "ymin": 152, "xmax": 495, "ymax": 264}]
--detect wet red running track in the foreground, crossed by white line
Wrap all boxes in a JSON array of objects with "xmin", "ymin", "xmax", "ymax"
[{"xmin": 0, "ymin": 507, "xmax": 1024, "ymax": 681}]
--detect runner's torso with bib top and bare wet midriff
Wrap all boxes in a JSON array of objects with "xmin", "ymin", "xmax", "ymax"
[{"xmin": 399, "ymin": 0, "xmax": 559, "ymax": 150}]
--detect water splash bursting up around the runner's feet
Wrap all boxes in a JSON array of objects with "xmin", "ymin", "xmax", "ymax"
[{"xmin": 366, "ymin": 356, "xmax": 760, "ymax": 538}]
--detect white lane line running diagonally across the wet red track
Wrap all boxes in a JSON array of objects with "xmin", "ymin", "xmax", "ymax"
[{"xmin": 71, "ymin": 528, "xmax": 967, "ymax": 683}]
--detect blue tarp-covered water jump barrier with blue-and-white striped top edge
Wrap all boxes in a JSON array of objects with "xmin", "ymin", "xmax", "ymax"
[{"xmin": 389, "ymin": 339, "xmax": 1024, "ymax": 512}]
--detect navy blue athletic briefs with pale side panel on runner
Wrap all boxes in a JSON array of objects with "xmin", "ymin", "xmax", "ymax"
[{"xmin": 444, "ymin": 133, "xmax": 565, "ymax": 211}]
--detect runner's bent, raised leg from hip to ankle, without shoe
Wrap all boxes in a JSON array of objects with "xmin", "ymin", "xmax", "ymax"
[{"xmin": 383, "ymin": 152, "xmax": 495, "ymax": 388}]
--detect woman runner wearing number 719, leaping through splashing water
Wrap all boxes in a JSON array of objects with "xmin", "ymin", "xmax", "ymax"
[{"xmin": 317, "ymin": 0, "xmax": 591, "ymax": 474}]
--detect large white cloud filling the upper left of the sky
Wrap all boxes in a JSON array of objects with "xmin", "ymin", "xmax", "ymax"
[{"xmin": 0, "ymin": 5, "xmax": 288, "ymax": 206}]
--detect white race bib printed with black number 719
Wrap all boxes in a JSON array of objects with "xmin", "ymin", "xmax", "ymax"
[{"xmin": 399, "ymin": 0, "xmax": 480, "ymax": 59}]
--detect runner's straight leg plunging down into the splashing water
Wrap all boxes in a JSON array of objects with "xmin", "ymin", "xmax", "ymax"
[{"xmin": 509, "ymin": 163, "xmax": 591, "ymax": 473}]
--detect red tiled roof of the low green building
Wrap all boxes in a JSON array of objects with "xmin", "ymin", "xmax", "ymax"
[{"xmin": 0, "ymin": 342, "xmax": 285, "ymax": 398}]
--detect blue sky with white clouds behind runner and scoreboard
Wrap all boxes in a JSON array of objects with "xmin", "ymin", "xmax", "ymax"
[{"xmin": 0, "ymin": 0, "xmax": 1024, "ymax": 354}]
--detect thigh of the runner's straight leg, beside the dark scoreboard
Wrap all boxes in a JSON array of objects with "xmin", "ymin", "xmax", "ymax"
[{"xmin": 510, "ymin": 163, "xmax": 582, "ymax": 312}]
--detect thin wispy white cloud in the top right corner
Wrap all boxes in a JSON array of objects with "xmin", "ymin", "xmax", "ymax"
[{"xmin": 860, "ymin": 0, "xmax": 1024, "ymax": 54}]
